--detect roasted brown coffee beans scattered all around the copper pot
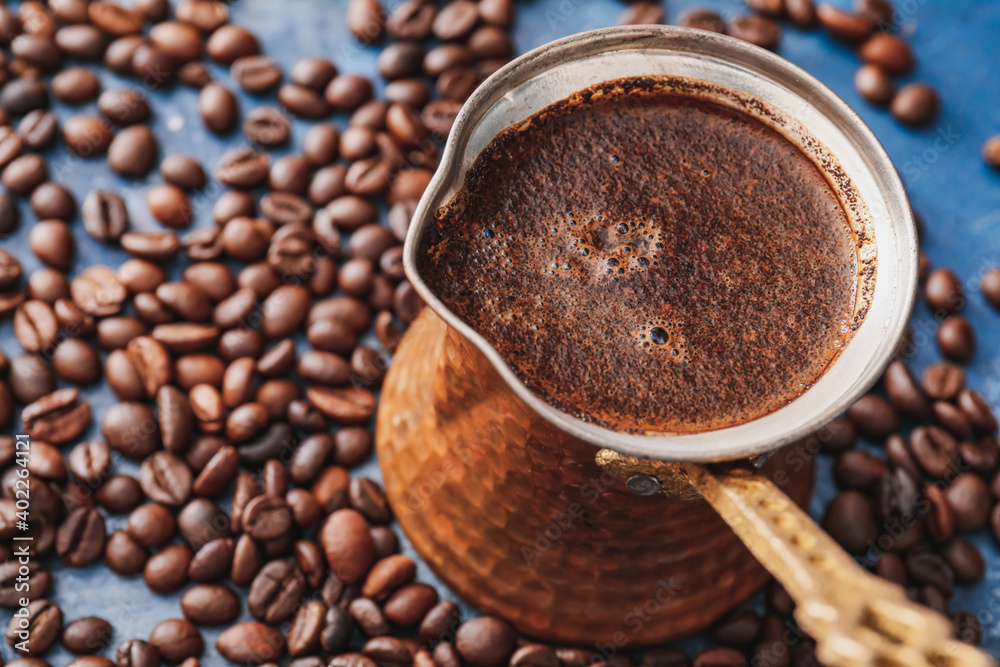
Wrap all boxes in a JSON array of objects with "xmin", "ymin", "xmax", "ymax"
[{"xmin": 0, "ymin": 0, "xmax": 1000, "ymax": 667}]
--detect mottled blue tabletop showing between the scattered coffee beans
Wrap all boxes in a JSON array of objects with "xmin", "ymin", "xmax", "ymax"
[{"xmin": 0, "ymin": 0, "xmax": 1000, "ymax": 667}]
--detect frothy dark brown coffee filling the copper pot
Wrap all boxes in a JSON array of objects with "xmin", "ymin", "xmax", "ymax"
[{"xmin": 417, "ymin": 77, "xmax": 866, "ymax": 434}]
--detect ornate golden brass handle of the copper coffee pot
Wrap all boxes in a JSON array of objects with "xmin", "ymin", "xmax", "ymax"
[{"xmin": 597, "ymin": 449, "xmax": 996, "ymax": 667}]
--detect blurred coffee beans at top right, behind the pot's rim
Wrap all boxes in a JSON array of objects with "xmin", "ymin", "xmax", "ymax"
[{"xmin": 619, "ymin": 0, "xmax": 936, "ymax": 129}]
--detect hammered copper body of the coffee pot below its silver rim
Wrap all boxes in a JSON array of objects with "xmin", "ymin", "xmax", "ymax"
[{"xmin": 378, "ymin": 308, "xmax": 813, "ymax": 646}]
